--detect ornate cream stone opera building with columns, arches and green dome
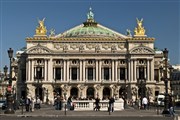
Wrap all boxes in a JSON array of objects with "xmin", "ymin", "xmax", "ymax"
[{"xmin": 17, "ymin": 9, "xmax": 169, "ymax": 102}]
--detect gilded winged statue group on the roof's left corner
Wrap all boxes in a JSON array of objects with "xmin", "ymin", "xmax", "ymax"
[{"xmin": 36, "ymin": 18, "xmax": 47, "ymax": 35}]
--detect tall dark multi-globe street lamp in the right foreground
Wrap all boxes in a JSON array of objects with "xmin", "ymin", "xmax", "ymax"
[{"xmin": 160, "ymin": 48, "xmax": 172, "ymax": 114}]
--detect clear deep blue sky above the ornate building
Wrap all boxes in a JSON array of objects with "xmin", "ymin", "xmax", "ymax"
[{"xmin": 0, "ymin": 0, "xmax": 180, "ymax": 70}]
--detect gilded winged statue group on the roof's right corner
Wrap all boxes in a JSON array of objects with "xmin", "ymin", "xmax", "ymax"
[{"xmin": 134, "ymin": 18, "xmax": 146, "ymax": 36}]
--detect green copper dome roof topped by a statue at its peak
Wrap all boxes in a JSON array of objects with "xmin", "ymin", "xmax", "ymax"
[{"xmin": 56, "ymin": 8, "xmax": 127, "ymax": 38}]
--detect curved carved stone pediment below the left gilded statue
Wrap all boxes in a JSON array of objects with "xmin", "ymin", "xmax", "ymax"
[{"xmin": 27, "ymin": 45, "xmax": 51, "ymax": 54}]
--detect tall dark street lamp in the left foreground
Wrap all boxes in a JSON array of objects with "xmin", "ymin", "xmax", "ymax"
[{"xmin": 4, "ymin": 48, "xmax": 15, "ymax": 114}]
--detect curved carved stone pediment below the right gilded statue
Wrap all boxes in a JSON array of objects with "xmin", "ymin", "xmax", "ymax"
[{"xmin": 130, "ymin": 46, "xmax": 155, "ymax": 54}]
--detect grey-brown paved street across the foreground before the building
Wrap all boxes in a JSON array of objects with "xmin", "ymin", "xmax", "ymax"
[{"xmin": 0, "ymin": 105, "xmax": 178, "ymax": 120}]
